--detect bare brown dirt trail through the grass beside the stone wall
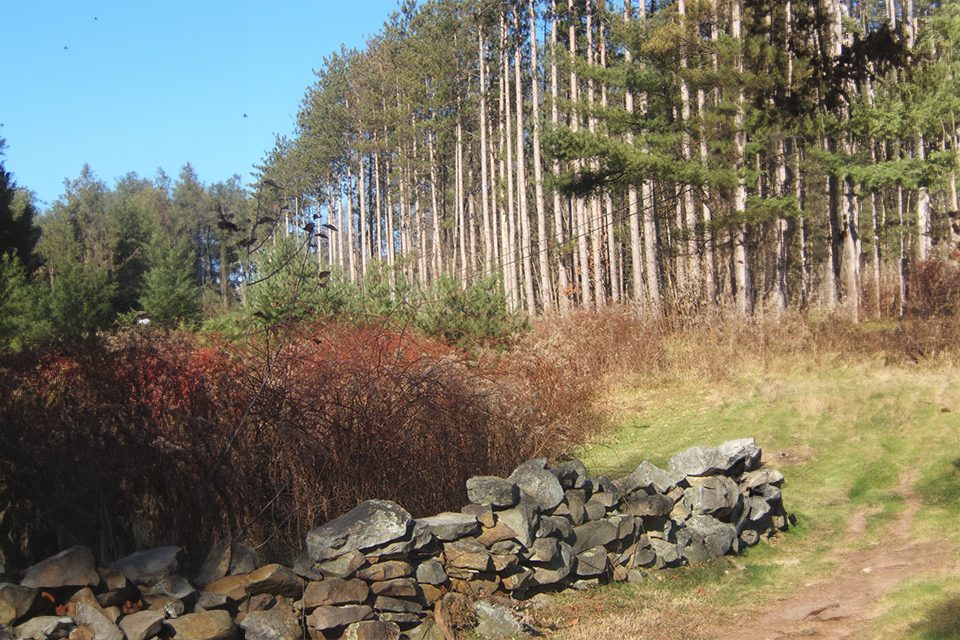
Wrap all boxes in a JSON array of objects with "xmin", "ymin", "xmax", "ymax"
[{"xmin": 710, "ymin": 478, "xmax": 958, "ymax": 640}]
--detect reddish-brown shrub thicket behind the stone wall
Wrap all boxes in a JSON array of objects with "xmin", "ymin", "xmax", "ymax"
[{"xmin": 0, "ymin": 325, "xmax": 594, "ymax": 568}]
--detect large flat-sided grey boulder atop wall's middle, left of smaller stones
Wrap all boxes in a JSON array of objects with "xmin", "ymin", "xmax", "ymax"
[{"xmin": 307, "ymin": 500, "xmax": 413, "ymax": 562}]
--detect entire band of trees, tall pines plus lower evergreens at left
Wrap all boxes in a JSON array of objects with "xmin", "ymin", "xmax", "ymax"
[{"xmin": 0, "ymin": 0, "xmax": 960, "ymax": 350}]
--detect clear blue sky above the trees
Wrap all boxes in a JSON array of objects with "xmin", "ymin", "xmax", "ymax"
[{"xmin": 0, "ymin": 0, "xmax": 398, "ymax": 207}]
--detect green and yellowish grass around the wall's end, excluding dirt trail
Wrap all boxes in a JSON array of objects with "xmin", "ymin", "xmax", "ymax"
[{"xmin": 544, "ymin": 357, "xmax": 960, "ymax": 639}]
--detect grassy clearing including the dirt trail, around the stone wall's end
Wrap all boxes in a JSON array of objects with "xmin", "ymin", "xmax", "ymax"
[{"xmin": 534, "ymin": 356, "xmax": 960, "ymax": 640}]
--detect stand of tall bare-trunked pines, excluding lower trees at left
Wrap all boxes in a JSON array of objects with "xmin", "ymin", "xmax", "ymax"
[{"xmin": 262, "ymin": 0, "xmax": 960, "ymax": 319}]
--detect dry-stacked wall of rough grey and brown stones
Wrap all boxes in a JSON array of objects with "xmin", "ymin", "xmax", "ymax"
[{"xmin": 0, "ymin": 439, "xmax": 788, "ymax": 640}]
